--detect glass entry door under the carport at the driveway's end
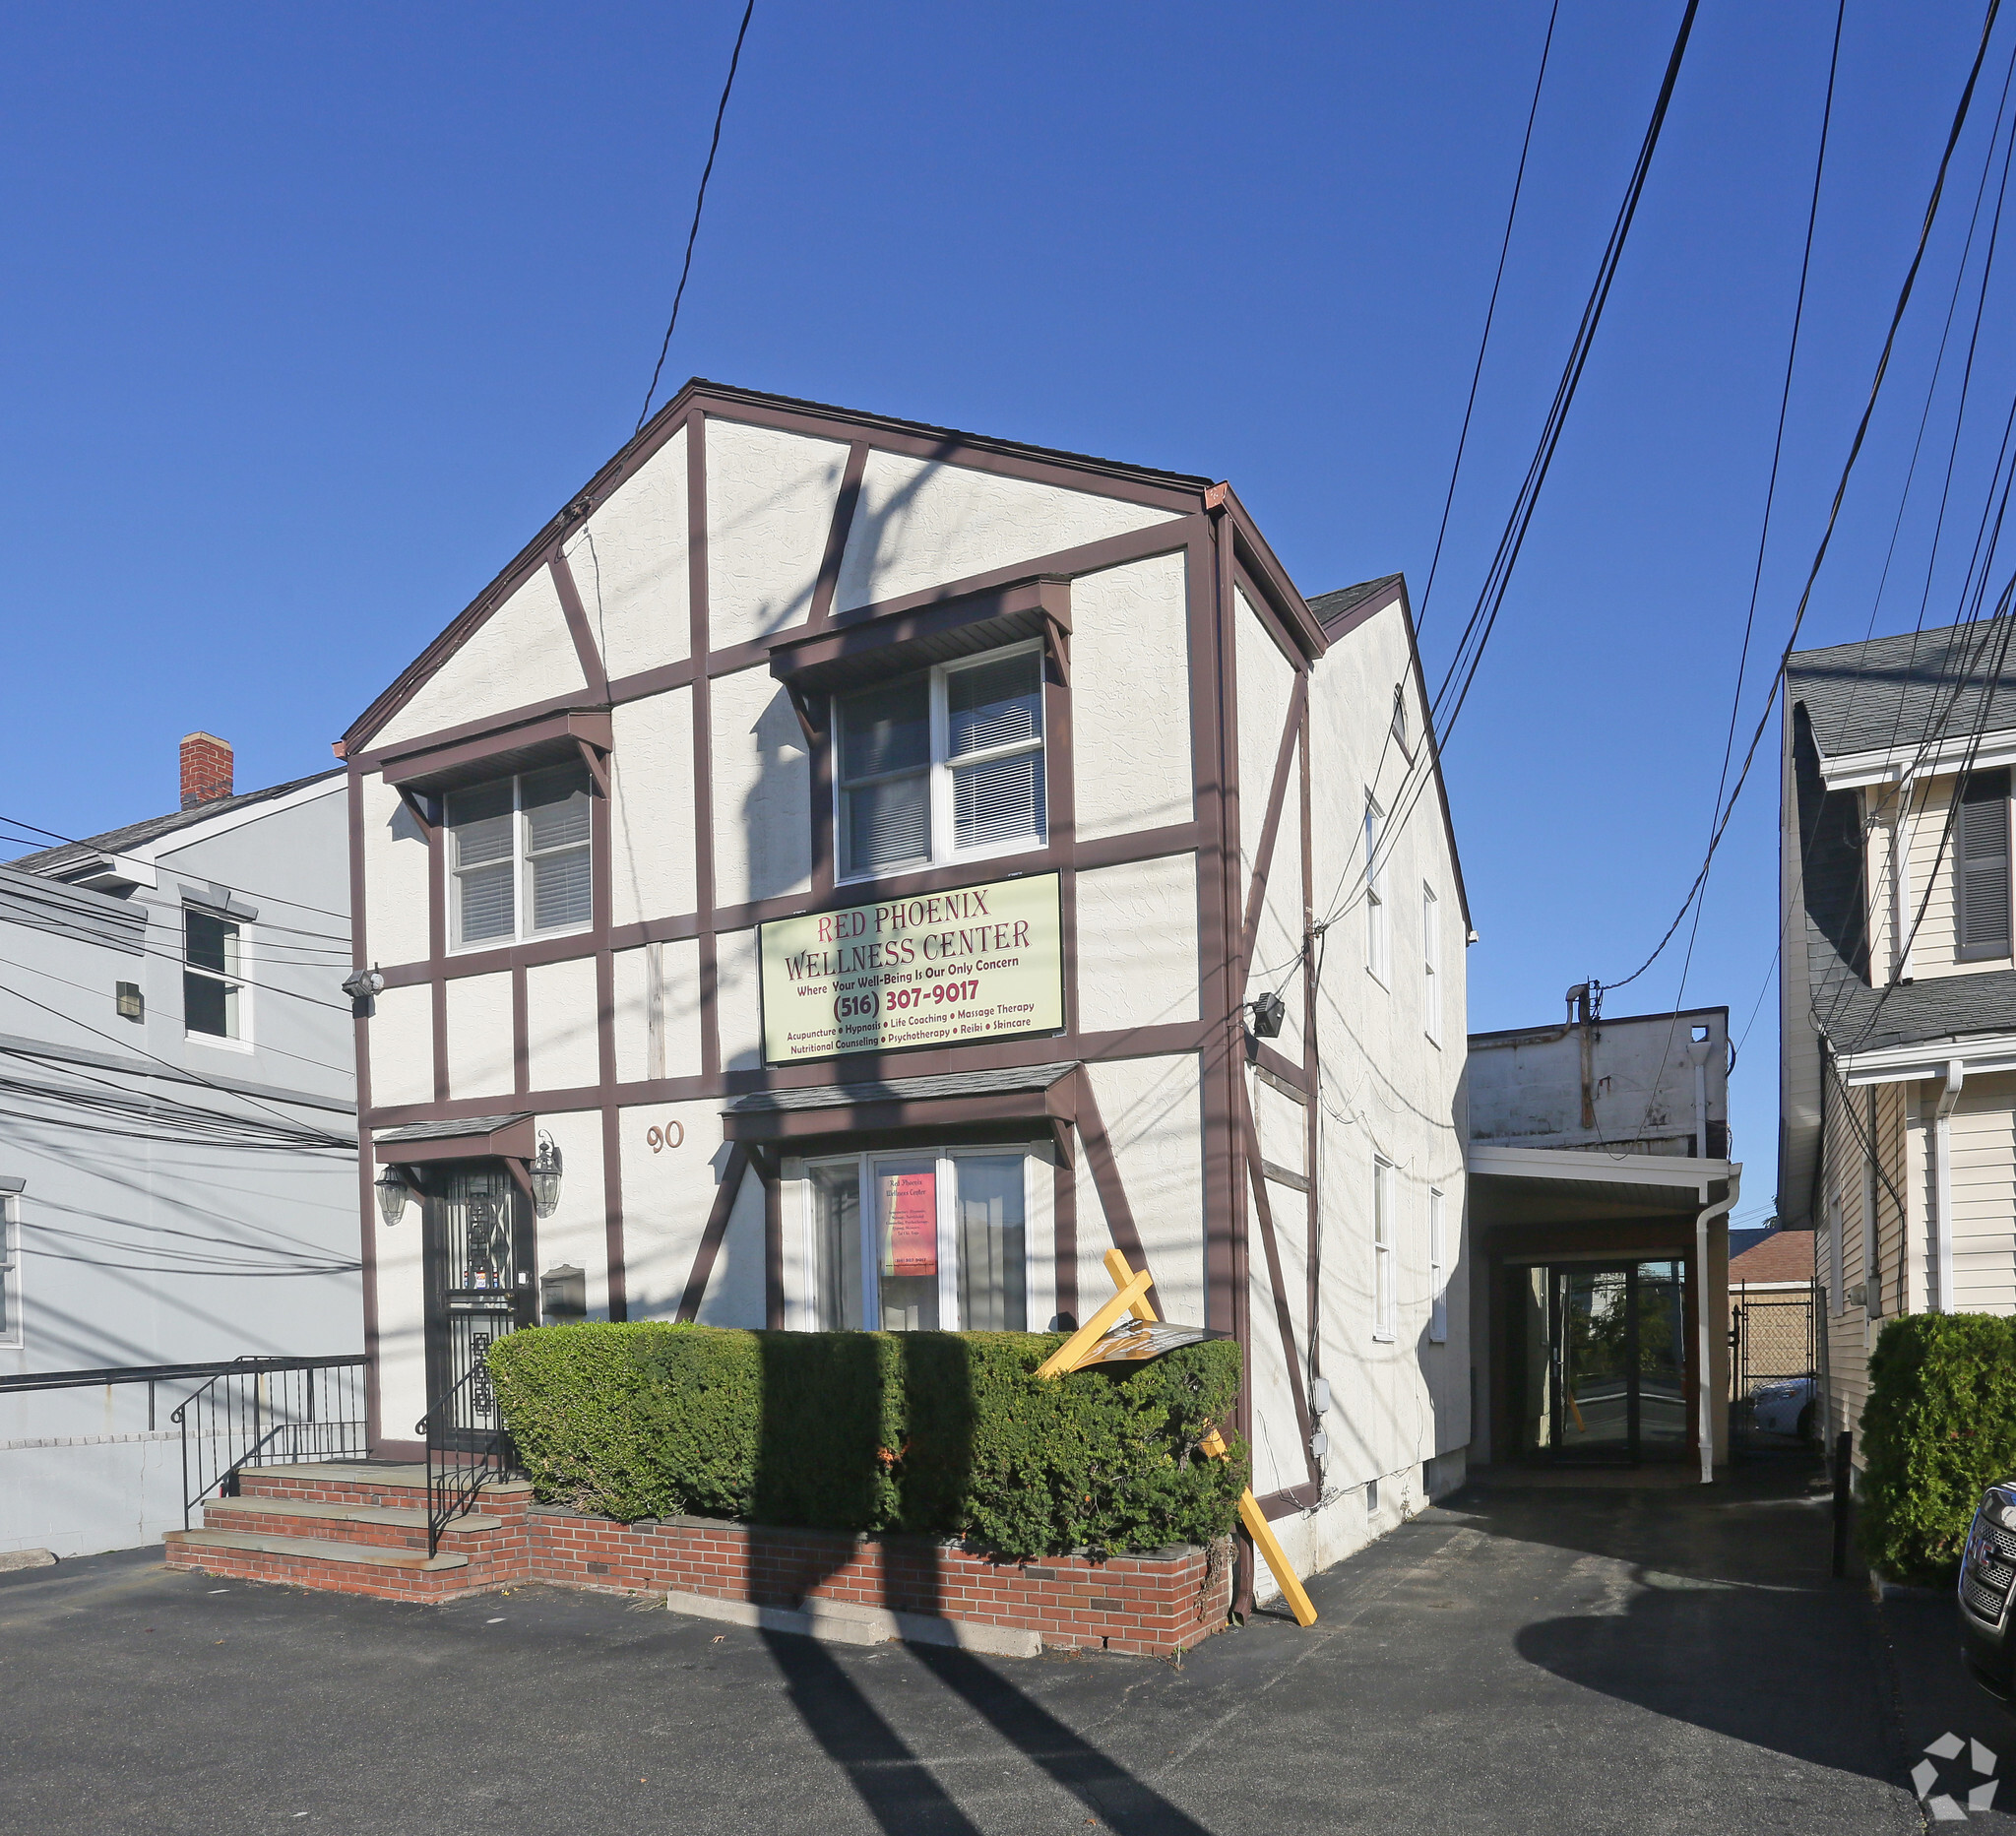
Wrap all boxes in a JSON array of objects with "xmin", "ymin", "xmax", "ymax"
[{"xmin": 1512, "ymin": 1260, "xmax": 1687, "ymax": 1463}]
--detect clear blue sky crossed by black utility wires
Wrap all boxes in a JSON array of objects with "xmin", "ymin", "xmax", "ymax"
[{"xmin": 0, "ymin": 0, "xmax": 2016, "ymax": 1218}]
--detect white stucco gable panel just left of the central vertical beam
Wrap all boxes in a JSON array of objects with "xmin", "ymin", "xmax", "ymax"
[{"xmin": 564, "ymin": 427, "xmax": 694, "ymax": 679}]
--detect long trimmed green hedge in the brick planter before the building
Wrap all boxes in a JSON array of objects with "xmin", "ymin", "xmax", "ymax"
[{"xmin": 490, "ymin": 1324, "xmax": 1248, "ymax": 1555}]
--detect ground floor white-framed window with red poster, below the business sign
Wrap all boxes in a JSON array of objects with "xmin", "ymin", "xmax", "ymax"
[{"xmin": 804, "ymin": 1147, "xmax": 1033, "ymax": 1332}]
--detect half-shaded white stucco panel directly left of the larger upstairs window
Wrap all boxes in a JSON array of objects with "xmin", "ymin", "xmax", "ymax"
[{"xmin": 712, "ymin": 669, "xmax": 812, "ymax": 905}]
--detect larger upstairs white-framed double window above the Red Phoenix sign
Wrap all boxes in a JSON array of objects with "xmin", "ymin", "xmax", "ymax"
[{"xmin": 833, "ymin": 641, "xmax": 1046, "ymax": 881}]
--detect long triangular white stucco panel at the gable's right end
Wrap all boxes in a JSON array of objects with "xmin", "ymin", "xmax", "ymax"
[{"xmin": 835, "ymin": 454, "xmax": 1171, "ymax": 610}]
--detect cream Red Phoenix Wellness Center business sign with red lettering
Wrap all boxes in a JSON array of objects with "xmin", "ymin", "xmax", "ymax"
[{"xmin": 760, "ymin": 872, "xmax": 1064, "ymax": 1064}]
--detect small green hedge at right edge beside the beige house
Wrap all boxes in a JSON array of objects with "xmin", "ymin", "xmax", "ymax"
[{"xmin": 1858, "ymin": 1314, "xmax": 2016, "ymax": 1584}]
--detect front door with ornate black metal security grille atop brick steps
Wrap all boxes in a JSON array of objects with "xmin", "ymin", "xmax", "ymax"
[{"xmin": 425, "ymin": 1161, "xmax": 536, "ymax": 1447}]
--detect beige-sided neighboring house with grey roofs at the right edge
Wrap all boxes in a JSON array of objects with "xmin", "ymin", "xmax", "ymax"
[{"xmin": 1778, "ymin": 621, "xmax": 2016, "ymax": 1467}]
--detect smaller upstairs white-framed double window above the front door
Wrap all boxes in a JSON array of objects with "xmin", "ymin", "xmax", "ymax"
[{"xmin": 446, "ymin": 764, "xmax": 595, "ymax": 949}]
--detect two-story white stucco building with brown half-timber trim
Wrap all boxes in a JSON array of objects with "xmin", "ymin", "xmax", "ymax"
[{"xmin": 343, "ymin": 381, "xmax": 1470, "ymax": 1604}]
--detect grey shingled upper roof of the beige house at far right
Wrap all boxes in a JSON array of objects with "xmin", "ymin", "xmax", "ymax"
[{"xmin": 1790, "ymin": 620, "xmax": 2016, "ymax": 758}]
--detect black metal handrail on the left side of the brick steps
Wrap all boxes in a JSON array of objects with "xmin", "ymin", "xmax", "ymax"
[{"xmin": 171, "ymin": 1355, "xmax": 371, "ymax": 1530}]
